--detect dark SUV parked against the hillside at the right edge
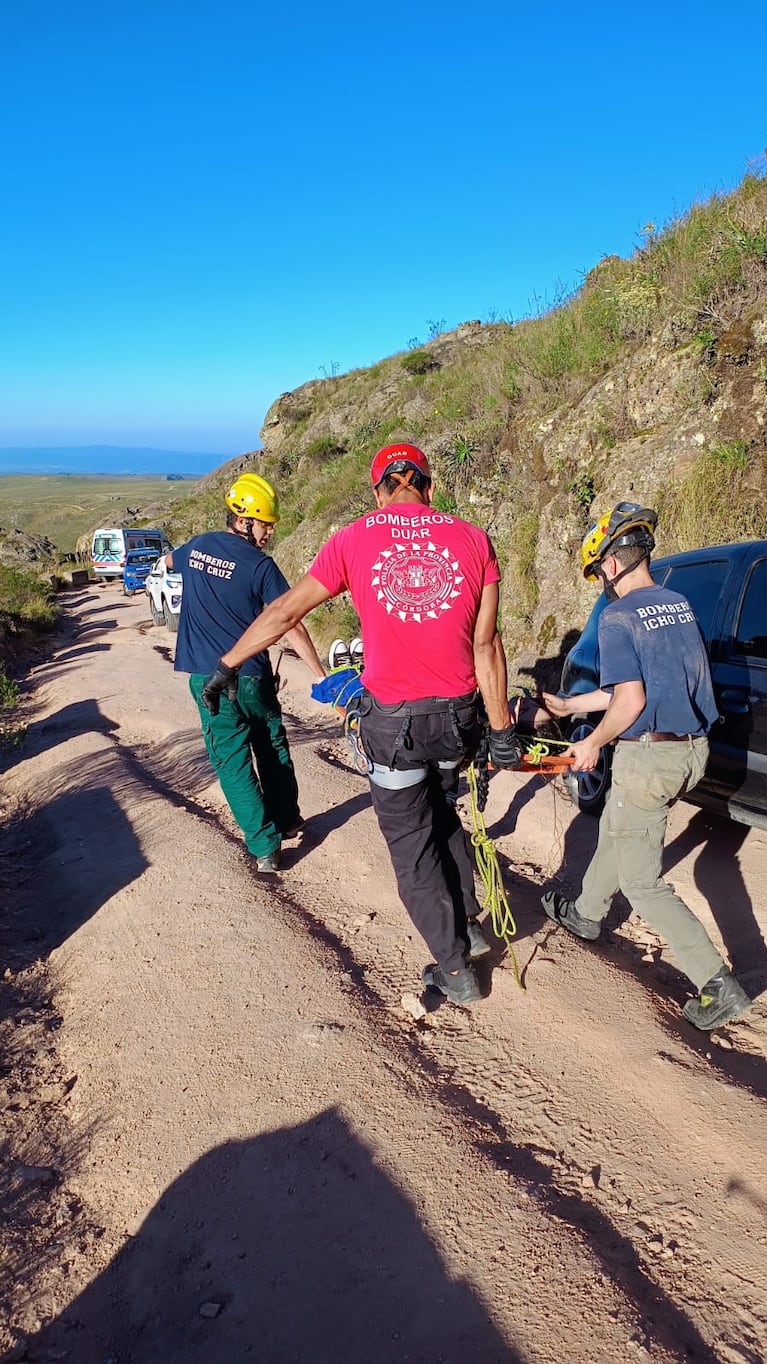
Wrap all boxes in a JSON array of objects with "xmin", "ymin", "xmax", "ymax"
[{"xmin": 560, "ymin": 540, "xmax": 767, "ymax": 828}]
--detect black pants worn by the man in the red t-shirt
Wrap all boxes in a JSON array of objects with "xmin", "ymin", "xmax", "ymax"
[{"xmin": 359, "ymin": 692, "xmax": 480, "ymax": 971}]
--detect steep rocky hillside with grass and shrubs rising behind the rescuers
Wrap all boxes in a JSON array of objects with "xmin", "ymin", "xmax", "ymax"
[{"xmin": 159, "ymin": 176, "xmax": 767, "ymax": 679}]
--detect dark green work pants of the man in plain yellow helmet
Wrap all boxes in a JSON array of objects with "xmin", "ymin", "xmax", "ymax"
[{"xmin": 190, "ymin": 672, "xmax": 300, "ymax": 857}]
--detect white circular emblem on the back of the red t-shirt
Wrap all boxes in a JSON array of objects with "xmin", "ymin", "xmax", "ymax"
[{"xmin": 371, "ymin": 540, "xmax": 464, "ymax": 622}]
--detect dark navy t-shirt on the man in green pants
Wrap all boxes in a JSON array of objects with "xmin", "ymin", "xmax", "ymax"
[{"xmin": 173, "ymin": 531, "xmax": 288, "ymax": 677}]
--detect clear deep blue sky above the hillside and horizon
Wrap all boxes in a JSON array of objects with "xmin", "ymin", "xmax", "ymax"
[{"xmin": 0, "ymin": 0, "xmax": 767, "ymax": 456}]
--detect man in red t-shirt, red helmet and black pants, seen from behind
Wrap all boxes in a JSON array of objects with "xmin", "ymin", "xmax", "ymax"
[{"xmin": 202, "ymin": 443, "xmax": 521, "ymax": 1004}]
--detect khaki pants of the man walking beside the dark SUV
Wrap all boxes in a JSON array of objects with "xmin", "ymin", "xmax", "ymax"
[{"xmin": 576, "ymin": 738, "xmax": 723, "ymax": 989}]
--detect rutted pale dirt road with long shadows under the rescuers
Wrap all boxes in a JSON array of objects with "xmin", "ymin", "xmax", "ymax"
[{"xmin": 0, "ymin": 587, "xmax": 767, "ymax": 1364}]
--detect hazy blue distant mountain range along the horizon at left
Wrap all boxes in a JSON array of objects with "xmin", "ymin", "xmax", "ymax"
[{"xmin": 0, "ymin": 445, "xmax": 229, "ymax": 479}]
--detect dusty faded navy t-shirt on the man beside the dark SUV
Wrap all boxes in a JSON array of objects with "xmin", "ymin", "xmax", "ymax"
[{"xmin": 599, "ymin": 587, "xmax": 719, "ymax": 738}]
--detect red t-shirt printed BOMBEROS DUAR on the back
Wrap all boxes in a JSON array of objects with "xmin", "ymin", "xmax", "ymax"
[{"xmin": 308, "ymin": 502, "xmax": 501, "ymax": 705}]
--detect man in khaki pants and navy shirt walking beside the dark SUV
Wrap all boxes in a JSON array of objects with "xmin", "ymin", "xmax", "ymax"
[{"xmin": 542, "ymin": 502, "xmax": 751, "ymax": 1030}]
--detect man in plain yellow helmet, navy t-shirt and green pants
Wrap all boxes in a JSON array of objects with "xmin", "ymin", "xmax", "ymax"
[{"xmin": 165, "ymin": 473, "xmax": 325, "ymax": 872}]
